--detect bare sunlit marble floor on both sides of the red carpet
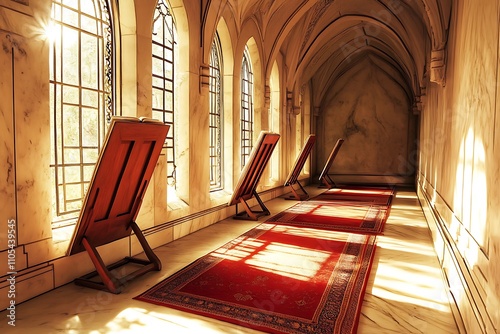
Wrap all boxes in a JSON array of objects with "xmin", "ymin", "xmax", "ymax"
[{"xmin": 0, "ymin": 187, "xmax": 465, "ymax": 334}]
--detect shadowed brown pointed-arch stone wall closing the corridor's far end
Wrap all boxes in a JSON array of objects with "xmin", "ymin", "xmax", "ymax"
[{"xmin": 315, "ymin": 56, "xmax": 416, "ymax": 184}]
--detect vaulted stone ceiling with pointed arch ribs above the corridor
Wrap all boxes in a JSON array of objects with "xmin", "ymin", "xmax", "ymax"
[{"xmin": 223, "ymin": 0, "xmax": 452, "ymax": 109}]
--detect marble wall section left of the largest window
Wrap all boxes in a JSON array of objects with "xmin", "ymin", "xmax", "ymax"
[{"xmin": 0, "ymin": 1, "xmax": 51, "ymax": 253}]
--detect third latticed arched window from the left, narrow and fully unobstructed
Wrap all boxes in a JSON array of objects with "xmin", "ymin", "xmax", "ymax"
[{"xmin": 209, "ymin": 34, "xmax": 222, "ymax": 191}]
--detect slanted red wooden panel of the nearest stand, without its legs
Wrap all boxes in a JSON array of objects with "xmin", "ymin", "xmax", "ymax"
[{"xmin": 68, "ymin": 117, "xmax": 170, "ymax": 255}]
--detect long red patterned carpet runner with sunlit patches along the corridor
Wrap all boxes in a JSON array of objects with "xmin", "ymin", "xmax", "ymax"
[{"xmin": 135, "ymin": 184, "xmax": 392, "ymax": 334}]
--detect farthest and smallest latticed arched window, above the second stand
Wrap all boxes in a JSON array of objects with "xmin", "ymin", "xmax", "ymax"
[{"xmin": 241, "ymin": 47, "xmax": 253, "ymax": 168}]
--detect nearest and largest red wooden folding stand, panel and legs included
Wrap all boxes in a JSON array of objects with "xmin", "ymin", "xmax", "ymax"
[{"xmin": 68, "ymin": 117, "xmax": 170, "ymax": 294}]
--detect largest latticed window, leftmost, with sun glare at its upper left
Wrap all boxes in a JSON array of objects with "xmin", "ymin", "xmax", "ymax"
[{"xmin": 47, "ymin": 0, "xmax": 113, "ymax": 223}]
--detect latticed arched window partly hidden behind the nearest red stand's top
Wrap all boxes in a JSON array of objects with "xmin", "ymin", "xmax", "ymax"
[{"xmin": 152, "ymin": 0, "xmax": 177, "ymax": 190}]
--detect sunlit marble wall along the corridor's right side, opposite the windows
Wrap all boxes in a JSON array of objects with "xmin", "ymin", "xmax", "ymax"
[{"xmin": 420, "ymin": 0, "xmax": 500, "ymax": 328}]
